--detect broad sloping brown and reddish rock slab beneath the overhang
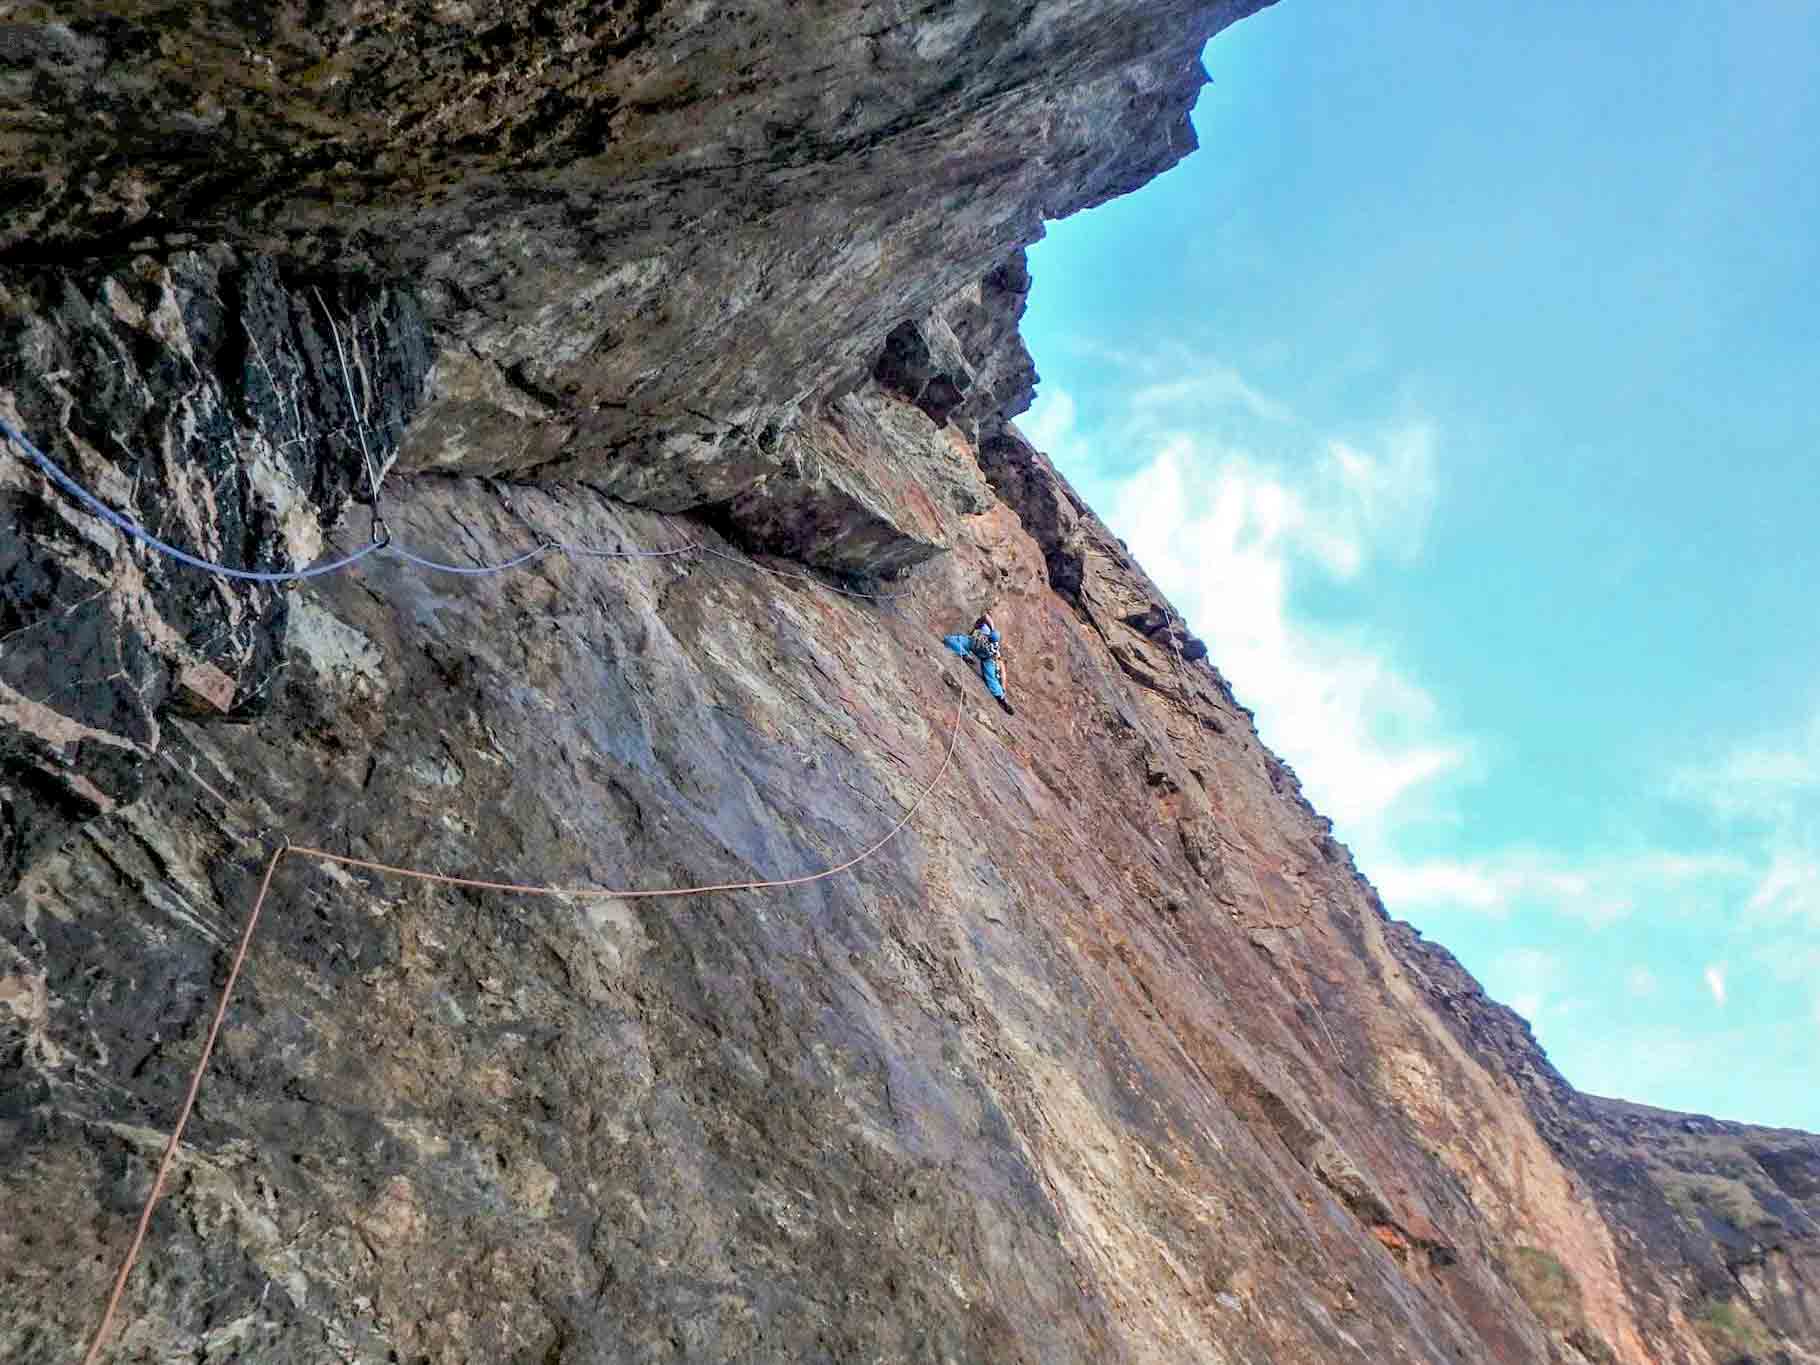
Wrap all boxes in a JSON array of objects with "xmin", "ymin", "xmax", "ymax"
[{"xmin": 4, "ymin": 460, "xmax": 1565, "ymax": 1360}]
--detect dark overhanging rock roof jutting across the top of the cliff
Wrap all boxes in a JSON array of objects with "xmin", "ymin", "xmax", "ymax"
[{"xmin": 0, "ymin": 0, "xmax": 1258, "ymax": 480}]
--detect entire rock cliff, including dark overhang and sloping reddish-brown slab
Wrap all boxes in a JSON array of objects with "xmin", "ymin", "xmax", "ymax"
[{"xmin": 0, "ymin": 0, "xmax": 1820, "ymax": 1365}]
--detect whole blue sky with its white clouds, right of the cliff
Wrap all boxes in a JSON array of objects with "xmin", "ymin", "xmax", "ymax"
[{"xmin": 1021, "ymin": 0, "xmax": 1820, "ymax": 1130}]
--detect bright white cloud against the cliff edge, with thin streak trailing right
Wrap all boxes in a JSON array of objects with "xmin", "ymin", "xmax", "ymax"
[{"xmin": 1021, "ymin": 364, "xmax": 1738, "ymax": 925}]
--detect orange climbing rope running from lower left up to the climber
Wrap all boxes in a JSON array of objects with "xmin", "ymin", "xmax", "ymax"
[{"xmin": 82, "ymin": 692, "xmax": 966, "ymax": 1365}]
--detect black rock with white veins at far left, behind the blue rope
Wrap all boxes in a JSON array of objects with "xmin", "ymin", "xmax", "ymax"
[{"xmin": 0, "ymin": 248, "xmax": 431, "ymax": 888}]
